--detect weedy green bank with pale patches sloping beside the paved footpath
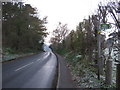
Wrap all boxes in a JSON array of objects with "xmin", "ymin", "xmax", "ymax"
[{"xmin": 58, "ymin": 50, "xmax": 115, "ymax": 88}]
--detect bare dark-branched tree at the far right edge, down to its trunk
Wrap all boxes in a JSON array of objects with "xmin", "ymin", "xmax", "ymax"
[{"xmin": 107, "ymin": 1, "xmax": 120, "ymax": 88}]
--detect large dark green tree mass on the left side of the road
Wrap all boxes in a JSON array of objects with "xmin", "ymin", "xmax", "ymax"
[{"xmin": 3, "ymin": 2, "xmax": 47, "ymax": 51}]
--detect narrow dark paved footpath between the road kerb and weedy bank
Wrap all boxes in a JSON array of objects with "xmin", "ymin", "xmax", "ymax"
[{"xmin": 57, "ymin": 54, "xmax": 76, "ymax": 88}]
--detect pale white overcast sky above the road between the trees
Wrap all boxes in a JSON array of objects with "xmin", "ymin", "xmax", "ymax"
[{"xmin": 25, "ymin": 0, "xmax": 105, "ymax": 41}]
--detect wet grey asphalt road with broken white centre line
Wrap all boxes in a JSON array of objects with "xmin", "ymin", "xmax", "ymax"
[{"xmin": 2, "ymin": 52, "xmax": 57, "ymax": 88}]
